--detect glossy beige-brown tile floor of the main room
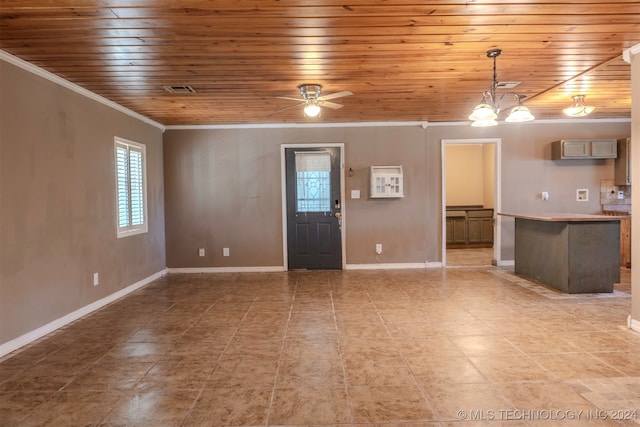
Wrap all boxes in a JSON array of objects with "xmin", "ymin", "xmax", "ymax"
[{"xmin": 0, "ymin": 267, "xmax": 640, "ymax": 427}]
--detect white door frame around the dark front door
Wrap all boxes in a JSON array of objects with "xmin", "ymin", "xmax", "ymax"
[{"xmin": 280, "ymin": 143, "xmax": 347, "ymax": 271}]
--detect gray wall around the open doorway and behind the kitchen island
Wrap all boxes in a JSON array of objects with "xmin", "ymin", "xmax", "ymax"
[{"xmin": 427, "ymin": 120, "xmax": 631, "ymax": 260}]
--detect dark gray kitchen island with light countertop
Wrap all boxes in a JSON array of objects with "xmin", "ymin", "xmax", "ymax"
[{"xmin": 499, "ymin": 213, "xmax": 620, "ymax": 294}]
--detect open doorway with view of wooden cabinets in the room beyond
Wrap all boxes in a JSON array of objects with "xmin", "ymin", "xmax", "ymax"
[{"xmin": 441, "ymin": 138, "xmax": 501, "ymax": 267}]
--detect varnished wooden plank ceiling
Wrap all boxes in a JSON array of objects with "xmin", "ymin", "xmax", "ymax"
[{"xmin": 0, "ymin": 0, "xmax": 640, "ymax": 125}]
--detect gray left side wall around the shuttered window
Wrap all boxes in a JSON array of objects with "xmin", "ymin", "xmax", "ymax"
[{"xmin": 0, "ymin": 61, "xmax": 166, "ymax": 344}]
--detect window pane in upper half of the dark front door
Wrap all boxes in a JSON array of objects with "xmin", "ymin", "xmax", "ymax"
[{"xmin": 296, "ymin": 152, "xmax": 331, "ymax": 212}]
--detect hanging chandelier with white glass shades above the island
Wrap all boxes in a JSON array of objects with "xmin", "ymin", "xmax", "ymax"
[{"xmin": 469, "ymin": 49, "xmax": 535, "ymax": 127}]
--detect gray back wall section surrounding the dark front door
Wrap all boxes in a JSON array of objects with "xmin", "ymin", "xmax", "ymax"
[{"xmin": 164, "ymin": 126, "xmax": 428, "ymax": 267}]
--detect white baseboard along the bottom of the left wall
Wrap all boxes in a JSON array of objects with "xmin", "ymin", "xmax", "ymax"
[{"xmin": 0, "ymin": 268, "xmax": 167, "ymax": 357}]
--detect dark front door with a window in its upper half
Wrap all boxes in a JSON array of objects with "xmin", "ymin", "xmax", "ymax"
[{"xmin": 285, "ymin": 147, "xmax": 342, "ymax": 270}]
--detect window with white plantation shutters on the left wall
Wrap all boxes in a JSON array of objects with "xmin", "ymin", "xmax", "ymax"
[{"xmin": 115, "ymin": 137, "xmax": 147, "ymax": 237}]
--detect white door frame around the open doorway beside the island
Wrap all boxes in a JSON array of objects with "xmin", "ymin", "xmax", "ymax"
[{"xmin": 440, "ymin": 138, "xmax": 502, "ymax": 267}]
